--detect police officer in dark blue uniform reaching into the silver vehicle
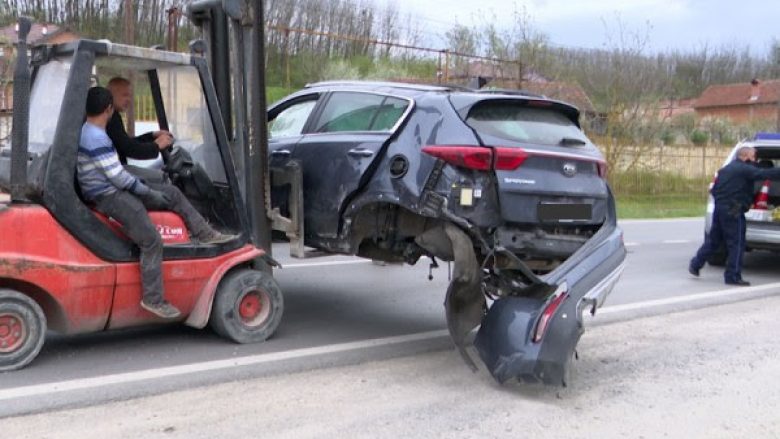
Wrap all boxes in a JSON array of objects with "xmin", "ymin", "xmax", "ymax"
[{"xmin": 688, "ymin": 146, "xmax": 780, "ymax": 286}]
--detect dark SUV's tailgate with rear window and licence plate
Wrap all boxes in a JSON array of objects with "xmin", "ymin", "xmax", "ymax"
[{"xmin": 465, "ymin": 99, "xmax": 608, "ymax": 224}]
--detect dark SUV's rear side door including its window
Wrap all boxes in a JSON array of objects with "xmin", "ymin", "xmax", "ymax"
[{"xmin": 292, "ymin": 91, "xmax": 412, "ymax": 241}]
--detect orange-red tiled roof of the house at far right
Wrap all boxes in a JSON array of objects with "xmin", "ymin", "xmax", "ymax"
[{"xmin": 693, "ymin": 79, "xmax": 780, "ymax": 108}]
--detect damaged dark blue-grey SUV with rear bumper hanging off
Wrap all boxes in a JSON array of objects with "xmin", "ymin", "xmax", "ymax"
[{"xmin": 268, "ymin": 81, "xmax": 626, "ymax": 385}]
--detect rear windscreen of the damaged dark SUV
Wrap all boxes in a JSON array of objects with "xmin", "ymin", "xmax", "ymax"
[{"xmin": 466, "ymin": 102, "xmax": 588, "ymax": 145}]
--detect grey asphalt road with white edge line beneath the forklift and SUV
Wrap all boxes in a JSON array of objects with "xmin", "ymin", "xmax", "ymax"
[{"xmin": 0, "ymin": 219, "xmax": 780, "ymax": 417}]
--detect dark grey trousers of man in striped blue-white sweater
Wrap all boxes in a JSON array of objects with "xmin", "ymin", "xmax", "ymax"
[{"xmin": 95, "ymin": 183, "xmax": 211, "ymax": 303}]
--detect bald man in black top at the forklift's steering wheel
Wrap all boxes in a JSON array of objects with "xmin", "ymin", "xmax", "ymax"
[{"xmin": 106, "ymin": 76, "xmax": 173, "ymax": 165}]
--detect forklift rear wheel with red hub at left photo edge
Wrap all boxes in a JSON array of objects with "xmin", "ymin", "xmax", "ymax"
[{"xmin": 0, "ymin": 289, "xmax": 46, "ymax": 372}]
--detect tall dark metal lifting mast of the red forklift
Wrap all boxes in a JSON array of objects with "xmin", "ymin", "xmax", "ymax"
[{"xmin": 187, "ymin": 0, "xmax": 271, "ymax": 264}]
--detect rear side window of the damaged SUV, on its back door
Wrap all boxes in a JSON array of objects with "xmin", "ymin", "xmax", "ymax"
[{"xmin": 313, "ymin": 92, "xmax": 409, "ymax": 133}]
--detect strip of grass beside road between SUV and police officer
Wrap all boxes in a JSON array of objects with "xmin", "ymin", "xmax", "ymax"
[{"xmin": 616, "ymin": 194, "xmax": 707, "ymax": 219}]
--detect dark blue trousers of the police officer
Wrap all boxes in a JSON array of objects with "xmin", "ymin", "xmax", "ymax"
[{"xmin": 691, "ymin": 204, "xmax": 745, "ymax": 282}]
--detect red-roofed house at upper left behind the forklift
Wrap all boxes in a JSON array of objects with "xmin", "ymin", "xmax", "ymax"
[{"xmin": 0, "ymin": 23, "xmax": 78, "ymax": 113}]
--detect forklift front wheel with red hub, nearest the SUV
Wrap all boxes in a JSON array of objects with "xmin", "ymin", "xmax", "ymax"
[{"xmin": 209, "ymin": 268, "xmax": 284, "ymax": 343}]
